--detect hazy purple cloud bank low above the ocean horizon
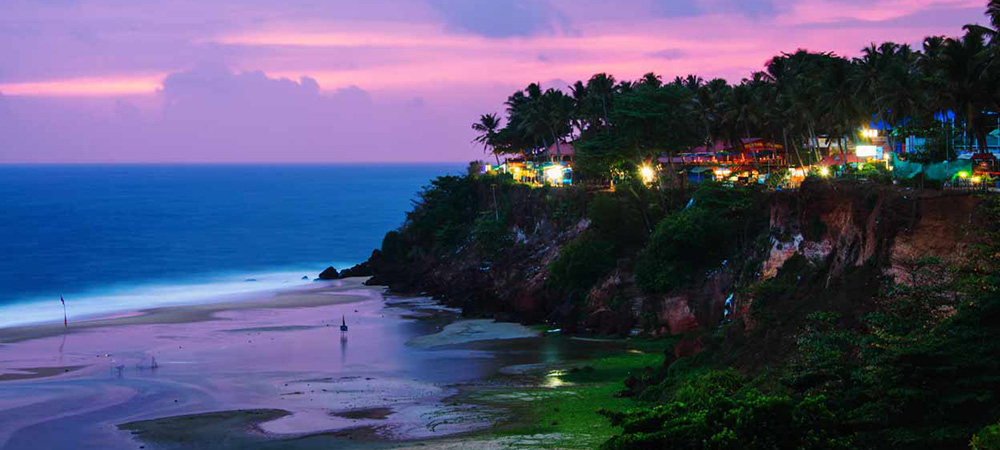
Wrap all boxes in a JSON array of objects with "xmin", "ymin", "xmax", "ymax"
[{"xmin": 0, "ymin": 66, "xmax": 480, "ymax": 162}]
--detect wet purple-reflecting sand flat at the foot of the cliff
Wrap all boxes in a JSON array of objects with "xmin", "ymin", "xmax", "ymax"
[{"xmin": 0, "ymin": 280, "xmax": 608, "ymax": 449}]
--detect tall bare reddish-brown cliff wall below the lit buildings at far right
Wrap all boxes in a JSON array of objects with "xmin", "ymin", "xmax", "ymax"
[{"xmin": 733, "ymin": 183, "xmax": 979, "ymax": 329}]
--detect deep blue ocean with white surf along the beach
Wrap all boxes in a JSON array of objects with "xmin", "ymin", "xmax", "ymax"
[{"xmin": 0, "ymin": 163, "xmax": 464, "ymax": 327}]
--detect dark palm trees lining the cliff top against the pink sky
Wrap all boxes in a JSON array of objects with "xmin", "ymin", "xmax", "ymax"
[{"xmin": 473, "ymin": 0, "xmax": 1000, "ymax": 179}]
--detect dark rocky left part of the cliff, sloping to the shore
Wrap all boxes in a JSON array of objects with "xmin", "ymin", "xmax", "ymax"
[{"xmin": 369, "ymin": 186, "xmax": 589, "ymax": 322}]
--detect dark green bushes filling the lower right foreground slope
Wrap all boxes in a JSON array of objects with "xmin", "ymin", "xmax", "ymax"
[{"xmin": 602, "ymin": 199, "xmax": 1000, "ymax": 450}]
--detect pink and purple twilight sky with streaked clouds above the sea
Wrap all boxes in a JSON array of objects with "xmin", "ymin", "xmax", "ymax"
[{"xmin": 0, "ymin": 0, "xmax": 987, "ymax": 163}]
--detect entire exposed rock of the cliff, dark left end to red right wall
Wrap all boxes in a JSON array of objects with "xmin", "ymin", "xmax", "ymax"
[{"xmin": 371, "ymin": 182, "xmax": 978, "ymax": 338}]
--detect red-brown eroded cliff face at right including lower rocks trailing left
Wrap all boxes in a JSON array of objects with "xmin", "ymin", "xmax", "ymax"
[{"xmin": 588, "ymin": 182, "xmax": 979, "ymax": 335}]
